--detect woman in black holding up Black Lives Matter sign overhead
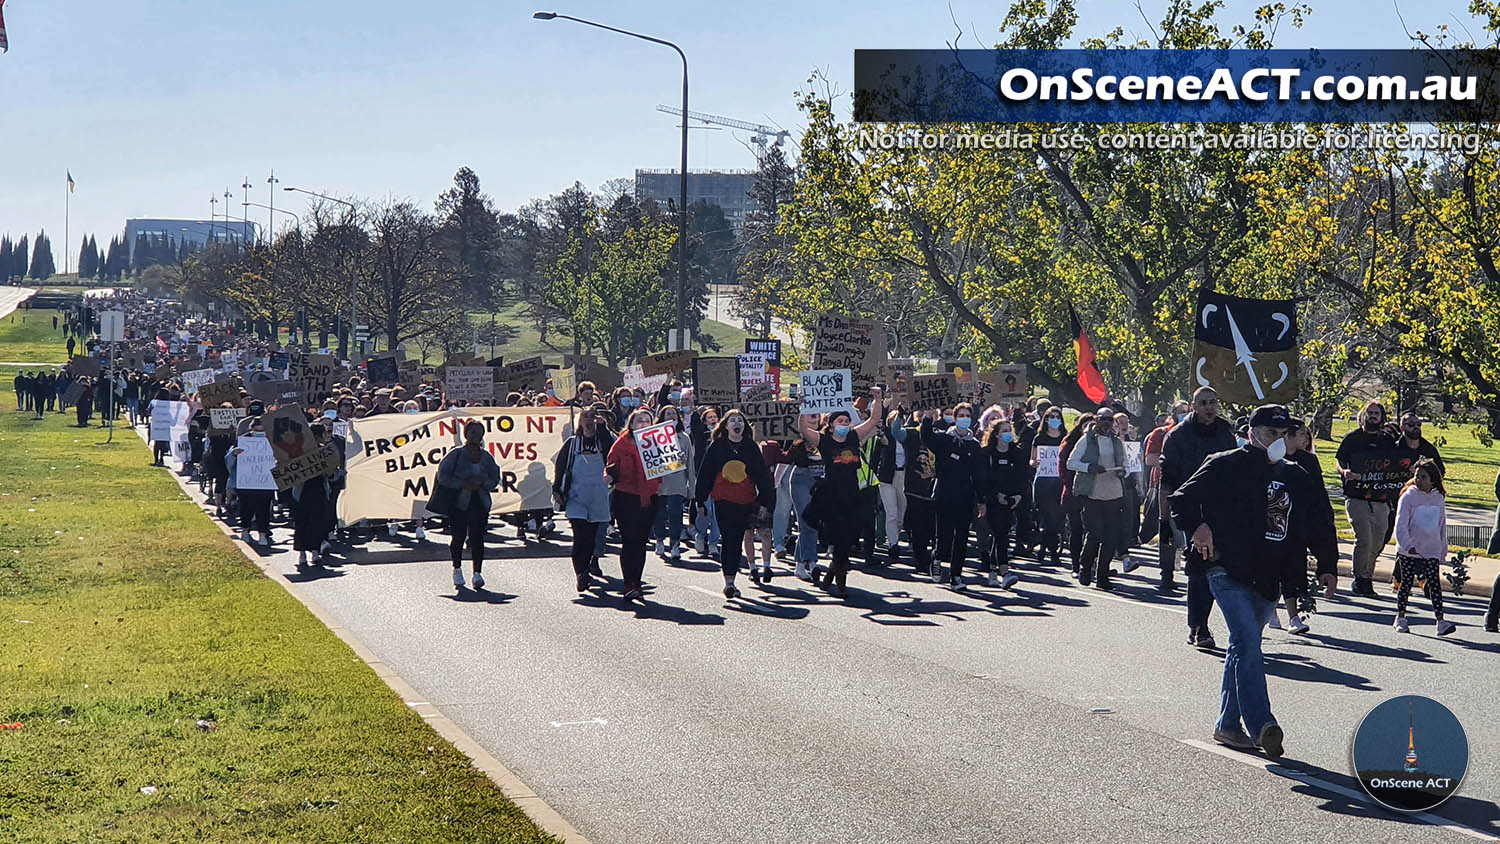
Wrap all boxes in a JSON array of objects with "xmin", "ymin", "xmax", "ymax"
[{"xmin": 800, "ymin": 387, "xmax": 885, "ymax": 598}]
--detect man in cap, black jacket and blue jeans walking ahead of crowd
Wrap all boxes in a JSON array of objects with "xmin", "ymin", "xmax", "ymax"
[{"xmin": 1172, "ymin": 405, "xmax": 1338, "ymax": 759}]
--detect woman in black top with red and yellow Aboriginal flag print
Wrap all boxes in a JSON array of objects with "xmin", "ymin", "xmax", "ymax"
[{"xmin": 695, "ymin": 411, "xmax": 776, "ymax": 598}]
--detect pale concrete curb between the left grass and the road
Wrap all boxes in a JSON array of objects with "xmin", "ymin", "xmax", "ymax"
[{"xmin": 133, "ymin": 424, "xmax": 591, "ymax": 844}]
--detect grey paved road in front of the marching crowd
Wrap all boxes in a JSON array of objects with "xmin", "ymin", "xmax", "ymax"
[{"xmin": 143, "ymin": 425, "xmax": 1500, "ymax": 844}]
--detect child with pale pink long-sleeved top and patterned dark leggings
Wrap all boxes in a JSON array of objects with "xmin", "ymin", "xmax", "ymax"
[{"xmin": 1395, "ymin": 457, "xmax": 1458, "ymax": 636}]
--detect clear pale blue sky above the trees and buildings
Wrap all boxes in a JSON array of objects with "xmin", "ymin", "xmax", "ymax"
[{"xmin": 0, "ymin": 0, "xmax": 1469, "ymax": 268}]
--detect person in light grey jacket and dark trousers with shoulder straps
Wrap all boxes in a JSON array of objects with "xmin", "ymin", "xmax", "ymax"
[{"xmin": 1068, "ymin": 408, "xmax": 1125, "ymax": 591}]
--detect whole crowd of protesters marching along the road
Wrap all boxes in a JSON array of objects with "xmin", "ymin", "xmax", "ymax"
[{"xmin": 15, "ymin": 292, "xmax": 1500, "ymax": 756}]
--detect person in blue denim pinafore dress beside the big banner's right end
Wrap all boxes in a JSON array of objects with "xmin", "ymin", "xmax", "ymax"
[{"xmin": 552, "ymin": 408, "xmax": 615, "ymax": 592}]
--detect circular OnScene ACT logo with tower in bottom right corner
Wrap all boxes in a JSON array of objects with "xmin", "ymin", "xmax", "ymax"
[{"xmin": 1352, "ymin": 694, "xmax": 1469, "ymax": 811}]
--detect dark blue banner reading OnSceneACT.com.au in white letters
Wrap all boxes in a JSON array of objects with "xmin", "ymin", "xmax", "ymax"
[{"xmin": 854, "ymin": 49, "xmax": 1500, "ymax": 123}]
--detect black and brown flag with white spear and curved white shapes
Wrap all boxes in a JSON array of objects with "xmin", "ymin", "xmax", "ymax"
[{"xmin": 1193, "ymin": 291, "xmax": 1299, "ymax": 405}]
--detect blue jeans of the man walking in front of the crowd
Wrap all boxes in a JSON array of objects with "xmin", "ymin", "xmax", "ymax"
[{"xmin": 1208, "ymin": 565, "xmax": 1277, "ymax": 738}]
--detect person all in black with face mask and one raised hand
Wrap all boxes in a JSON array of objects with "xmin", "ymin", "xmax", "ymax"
[{"xmin": 921, "ymin": 402, "xmax": 986, "ymax": 592}]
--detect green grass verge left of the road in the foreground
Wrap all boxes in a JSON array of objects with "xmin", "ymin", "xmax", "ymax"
[{"xmin": 0, "ymin": 358, "xmax": 548, "ymax": 843}]
